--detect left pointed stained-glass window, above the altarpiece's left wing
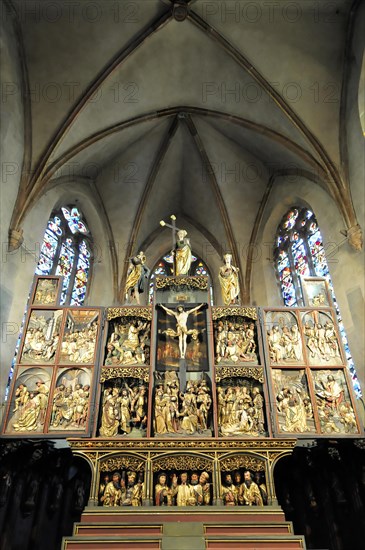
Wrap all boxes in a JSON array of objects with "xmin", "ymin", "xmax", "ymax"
[{"xmin": 35, "ymin": 206, "xmax": 92, "ymax": 306}]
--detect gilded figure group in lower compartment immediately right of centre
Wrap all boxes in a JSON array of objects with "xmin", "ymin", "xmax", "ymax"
[{"xmin": 217, "ymin": 385, "xmax": 266, "ymax": 436}]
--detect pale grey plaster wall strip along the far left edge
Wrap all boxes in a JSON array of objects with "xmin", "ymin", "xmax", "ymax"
[{"xmin": 0, "ymin": 9, "xmax": 27, "ymax": 420}]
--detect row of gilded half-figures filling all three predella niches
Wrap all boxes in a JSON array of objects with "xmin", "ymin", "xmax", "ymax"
[{"xmin": 98, "ymin": 470, "xmax": 268, "ymax": 507}]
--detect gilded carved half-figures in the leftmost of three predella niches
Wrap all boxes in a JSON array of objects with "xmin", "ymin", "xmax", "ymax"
[{"xmin": 99, "ymin": 471, "xmax": 143, "ymax": 507}]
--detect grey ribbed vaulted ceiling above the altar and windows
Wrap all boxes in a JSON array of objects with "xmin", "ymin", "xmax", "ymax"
[{"xmin": 7, "ymin": 0, "xmax": 354, "ymax": 302}]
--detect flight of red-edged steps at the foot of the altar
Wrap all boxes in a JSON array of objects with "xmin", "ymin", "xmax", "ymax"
[{"xmin": 62, "ymin": 506, "xmax": 305, "ymax": 550}]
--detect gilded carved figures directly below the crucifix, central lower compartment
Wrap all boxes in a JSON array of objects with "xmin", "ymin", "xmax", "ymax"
[{"xmin": 153, "ymin": 373, "xmax": 212, "ymax": 435}]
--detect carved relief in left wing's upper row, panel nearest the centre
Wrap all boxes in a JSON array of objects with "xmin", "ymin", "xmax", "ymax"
[{"xmin": 61, "ymin": 322, "xmax": 98, "ymax": 364}]
